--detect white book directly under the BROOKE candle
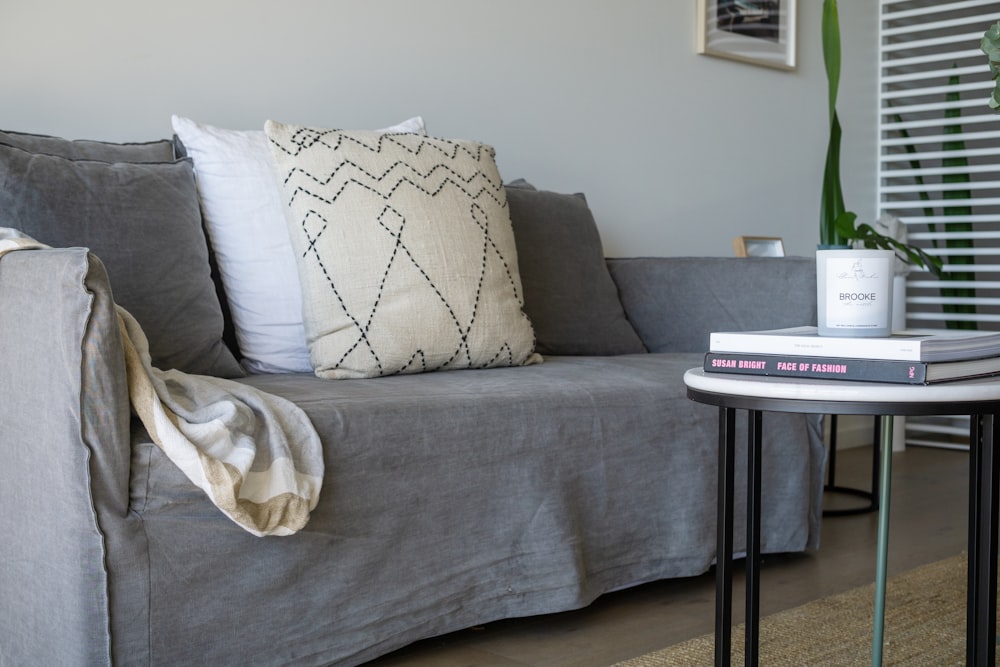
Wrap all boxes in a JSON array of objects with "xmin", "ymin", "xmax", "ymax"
[{"xmin": 709, "ymin": 326, "xmax": 1000, "ymax": 361}]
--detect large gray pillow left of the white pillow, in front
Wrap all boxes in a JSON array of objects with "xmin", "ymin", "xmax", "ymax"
[{"xmin": 0, "ymin": 144, "xmax": 243, "ymax": 377}]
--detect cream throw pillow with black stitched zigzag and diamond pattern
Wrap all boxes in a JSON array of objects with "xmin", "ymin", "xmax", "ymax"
[{"xmin": 265, "ymin": 121, "xmax": 541, "ymax": 379}]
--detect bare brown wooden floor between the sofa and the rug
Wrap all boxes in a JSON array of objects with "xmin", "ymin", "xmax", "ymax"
[{"xmin": 369, "ymin": 448, "xmax": 969, "ymax": 667}]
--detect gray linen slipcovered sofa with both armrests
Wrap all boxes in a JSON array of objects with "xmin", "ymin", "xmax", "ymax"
[{"xmin": 0, "ymin": 128, "xmax": 824, "ymax": 665}]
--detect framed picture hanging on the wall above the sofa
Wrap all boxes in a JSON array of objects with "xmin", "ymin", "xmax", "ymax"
[{"xmin": 696, "ymin": 0, "xmax": 798, "ymax": 70}]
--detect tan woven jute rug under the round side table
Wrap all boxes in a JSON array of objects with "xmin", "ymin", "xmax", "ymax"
[{"xmin": 615, "ymin": 555, "xmax": 984, "ymax": 667}]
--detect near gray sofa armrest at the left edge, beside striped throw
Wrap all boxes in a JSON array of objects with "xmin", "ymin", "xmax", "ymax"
[{"xmin": 0, "ymin": 248, "xmax": 130, "ymax": 664}]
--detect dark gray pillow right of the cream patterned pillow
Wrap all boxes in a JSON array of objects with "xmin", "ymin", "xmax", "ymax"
[{"xmin": 507, "ymin": 180, "xmax": 646, "ymax": 355}]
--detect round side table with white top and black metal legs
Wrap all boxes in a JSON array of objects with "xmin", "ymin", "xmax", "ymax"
[{"xmin": 684, "ymin": 368, "xmax": 1000, "ymax": 666}]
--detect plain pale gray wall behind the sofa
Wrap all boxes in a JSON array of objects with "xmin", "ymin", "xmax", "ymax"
[{"xmin": 0, "ymin": 0, "xmax": 877, "ymax": 256}]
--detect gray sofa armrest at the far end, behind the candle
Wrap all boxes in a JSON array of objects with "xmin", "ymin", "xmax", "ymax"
[{"xmin": 608, "ymin": 257, "xmax": 816, "ymax": 352}]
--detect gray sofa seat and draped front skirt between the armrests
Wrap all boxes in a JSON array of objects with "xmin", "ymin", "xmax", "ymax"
[{"xmin": 131, "ymin": 353, "xmax": 823, "ymax": 664}]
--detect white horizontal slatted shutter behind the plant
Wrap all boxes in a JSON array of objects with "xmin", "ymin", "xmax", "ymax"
[{"xmin": 878, "ymin": 0, "xmax": 1000, "ymax": 448}]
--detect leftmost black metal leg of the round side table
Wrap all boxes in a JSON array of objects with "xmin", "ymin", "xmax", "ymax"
[{"xmin": 715, "ymin": 407, "xmax": 736, "ymax": 667}]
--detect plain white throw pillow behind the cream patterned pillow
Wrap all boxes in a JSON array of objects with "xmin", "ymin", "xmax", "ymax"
[{"xmin": 172, "ymin": 115, "xmax": 425, "ymax": 373}]
